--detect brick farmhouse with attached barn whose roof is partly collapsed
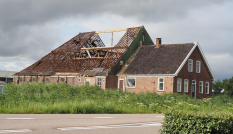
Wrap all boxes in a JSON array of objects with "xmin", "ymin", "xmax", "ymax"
[{"xmin": 13, "ymin": 26, "xmax": 215, "ymax": 98}]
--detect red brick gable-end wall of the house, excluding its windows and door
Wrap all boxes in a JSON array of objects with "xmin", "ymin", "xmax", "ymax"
[{"xmin": 173, "ymin": 48, "xmax": 212, "ymax": 98}]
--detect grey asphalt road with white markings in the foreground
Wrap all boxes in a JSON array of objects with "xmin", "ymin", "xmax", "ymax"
[{"xmin": 0, "ymin": 114, "xmax": 164, "ymax": 134}]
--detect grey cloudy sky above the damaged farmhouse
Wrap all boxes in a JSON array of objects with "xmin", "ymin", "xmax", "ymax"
[{"xmin": 0, "ymin": 0, "xmax": 233, "ymax": 79}]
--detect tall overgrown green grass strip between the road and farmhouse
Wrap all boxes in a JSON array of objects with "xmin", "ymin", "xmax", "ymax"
[{"xmin": 0, "ymin": 83, "xmax": 233, "ymax": 116}]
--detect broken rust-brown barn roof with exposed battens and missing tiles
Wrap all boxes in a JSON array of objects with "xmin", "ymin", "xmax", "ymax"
[{"xmin": 15, "ymin": 26, "xmax": 144, "ymax": 75}]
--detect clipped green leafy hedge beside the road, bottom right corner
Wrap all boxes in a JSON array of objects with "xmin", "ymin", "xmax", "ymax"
[{"xmin": 161, "ymin": 111, "xmax": 233, "ymax": 134}]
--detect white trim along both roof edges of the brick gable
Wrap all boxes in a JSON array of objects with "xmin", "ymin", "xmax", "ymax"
[{"xmin": 175, "ymin": 42, "xmax": 215, "ymax": 81}]
